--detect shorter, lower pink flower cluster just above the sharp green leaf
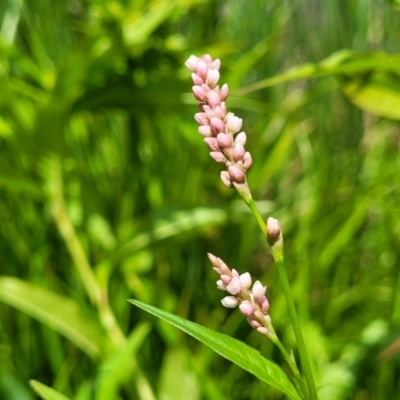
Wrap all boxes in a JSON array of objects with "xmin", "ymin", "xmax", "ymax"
[{"xmin": 208, "ymin": 253, "xmax": 276, "ymax": 338}]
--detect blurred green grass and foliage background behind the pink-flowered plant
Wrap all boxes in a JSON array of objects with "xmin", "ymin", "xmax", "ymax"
[{"xmin": 0, "ymin": 0, "xmax": 400, "ymax": 400}]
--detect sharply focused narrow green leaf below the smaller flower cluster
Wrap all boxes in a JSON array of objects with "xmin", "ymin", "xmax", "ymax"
[{"xmin": 129, "ymin": 300, "xmax": 301, "ymax": 400}]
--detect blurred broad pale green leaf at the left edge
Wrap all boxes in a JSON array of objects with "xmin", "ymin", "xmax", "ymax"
[{"xmin": 0, "ymin": 277, "xmax": 104, "ymax": 358}]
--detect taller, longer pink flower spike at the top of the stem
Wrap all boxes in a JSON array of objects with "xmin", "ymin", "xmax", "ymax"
[{"xmin": 185, "ymin": 54, "xmax": 253, "ymax": 187}]
